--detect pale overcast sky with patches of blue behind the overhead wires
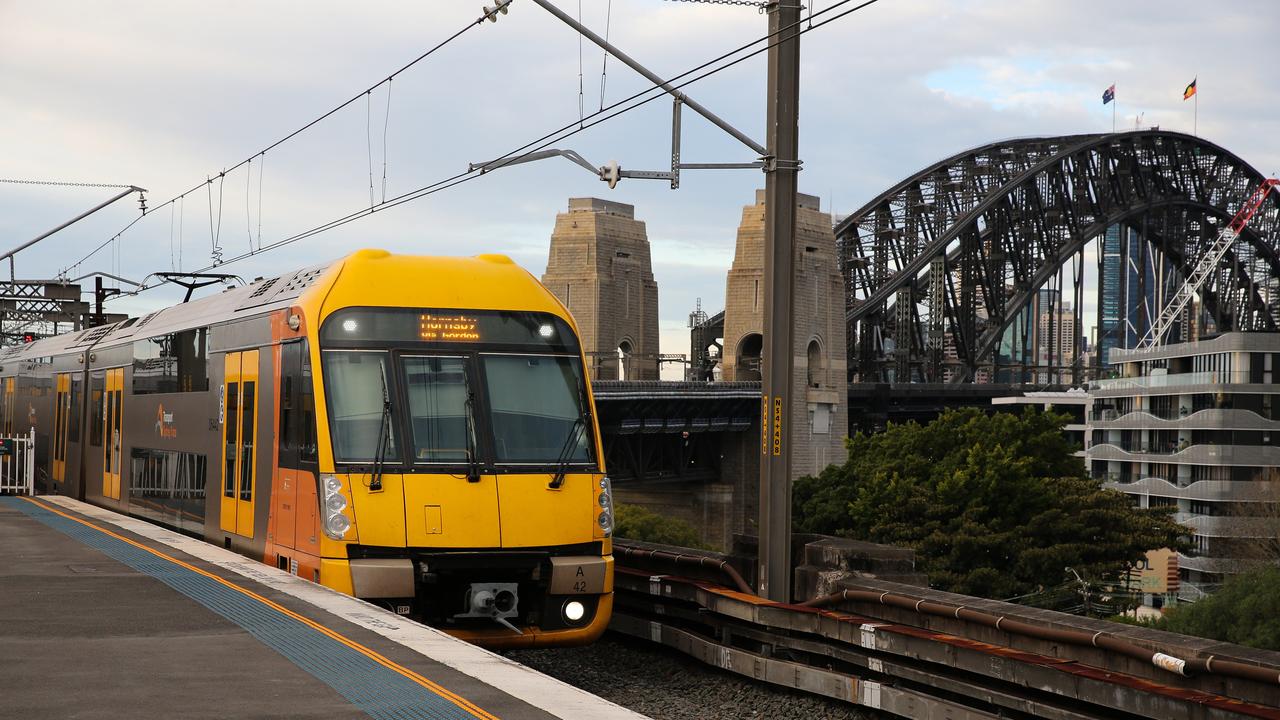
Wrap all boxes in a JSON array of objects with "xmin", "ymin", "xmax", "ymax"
[{"xmin": 0, "ymin": 0, "xmax": 1280, "ymax": 366}]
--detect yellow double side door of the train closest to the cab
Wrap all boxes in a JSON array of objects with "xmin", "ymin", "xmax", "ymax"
[{"xmin": 219, "ymin": 350, "xmax": 259, "ymax": 538}]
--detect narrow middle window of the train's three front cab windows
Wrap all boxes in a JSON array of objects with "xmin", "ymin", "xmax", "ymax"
[{"xmin": 404, "ymin": 356, "xmax": 475, "ymax": 464}]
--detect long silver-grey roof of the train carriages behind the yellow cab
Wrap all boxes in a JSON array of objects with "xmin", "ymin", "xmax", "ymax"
[{"xmin": 0, "ymin": 257, "xmax": 333, "ymax": 365}]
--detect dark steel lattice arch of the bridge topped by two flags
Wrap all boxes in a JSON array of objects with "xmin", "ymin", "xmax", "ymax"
[{"xmin": 836, "ymin": 129, "xmax": 1280, "ymax": 384}]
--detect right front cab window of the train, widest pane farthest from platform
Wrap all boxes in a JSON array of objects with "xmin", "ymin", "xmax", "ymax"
[{"xmin": 480, "ymin": 355, "xmax": 593, "ymax": 465}]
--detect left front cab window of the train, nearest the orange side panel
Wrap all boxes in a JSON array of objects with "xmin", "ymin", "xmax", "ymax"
[{"xmin": 324, "ymin": 350, "xmax": 399, "ymax": 462}]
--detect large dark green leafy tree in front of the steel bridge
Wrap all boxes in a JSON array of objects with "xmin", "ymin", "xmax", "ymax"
[{"xmin": 794, "ymin": 407, "xmax": 1187, "ymax": 598}]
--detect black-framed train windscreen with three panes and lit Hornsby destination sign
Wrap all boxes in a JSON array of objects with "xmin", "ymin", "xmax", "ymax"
[{"xmin": 320, "ymin": 307, "xmax": 596, "ymax": 473}]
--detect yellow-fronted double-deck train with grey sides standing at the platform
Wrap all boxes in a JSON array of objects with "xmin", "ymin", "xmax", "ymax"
[{"xmin": 0, "ymin": 250, "xmax": 613, "ymax": 647}]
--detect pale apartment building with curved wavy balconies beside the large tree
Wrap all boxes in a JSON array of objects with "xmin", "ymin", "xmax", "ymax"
[{"xmin": 1085, "ymin": 333, "xmax": 1280, "ymax": 606}]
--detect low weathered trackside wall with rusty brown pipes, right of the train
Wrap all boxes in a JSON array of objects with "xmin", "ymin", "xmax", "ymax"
[{"xmin": 611, "ymin": 542, "xmax": 1280, "ymax": 720}]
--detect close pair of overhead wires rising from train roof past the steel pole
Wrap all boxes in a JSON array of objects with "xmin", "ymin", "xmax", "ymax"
[{"xmin": 104, "ymin": 0, "xmax": 879, "ymax": 297}]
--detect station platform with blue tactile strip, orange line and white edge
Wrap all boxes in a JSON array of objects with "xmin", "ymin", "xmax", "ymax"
[{"xmin": 0, "ymin": 497, "xmax": 641, "ymax": 720}]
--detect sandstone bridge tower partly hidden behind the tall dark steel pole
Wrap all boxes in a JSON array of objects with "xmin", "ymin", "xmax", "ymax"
[{"xmin": 723, "ymin": 190, "xmax": 849, "ymax": 477}]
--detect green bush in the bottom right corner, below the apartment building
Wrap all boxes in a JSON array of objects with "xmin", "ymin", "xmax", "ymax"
[{"xmin": 1156, "ymin": 568, "xmax": 1280, "ymax": 650}]
